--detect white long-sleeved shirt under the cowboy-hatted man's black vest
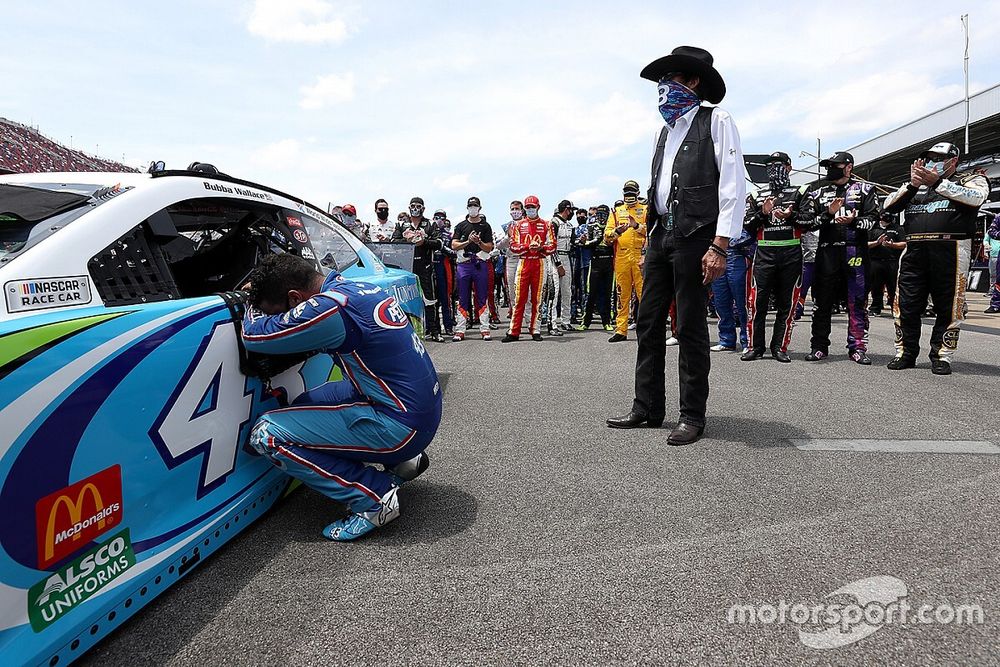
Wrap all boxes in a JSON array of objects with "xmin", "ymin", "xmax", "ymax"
[{"xmin": 656, "ymin": 107, "xmax": 747, "ymax": 239}]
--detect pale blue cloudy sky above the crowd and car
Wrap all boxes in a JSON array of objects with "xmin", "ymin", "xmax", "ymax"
[{"xmin": 0, "ymin": 0, "xmax": 1000, "ymax": 219}]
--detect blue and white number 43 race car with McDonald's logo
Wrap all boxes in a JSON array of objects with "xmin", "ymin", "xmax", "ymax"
[{"xmin": 0, "ymin": 164, "xmax": 424, "ymax": 666}]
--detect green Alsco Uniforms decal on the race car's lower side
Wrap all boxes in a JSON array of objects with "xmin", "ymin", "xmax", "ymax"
[{"xmin": 28, "ymin": 528, "xmax": 135, "ymax": 632}]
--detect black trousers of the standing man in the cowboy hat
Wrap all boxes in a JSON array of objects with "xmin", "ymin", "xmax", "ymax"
[{"xmin": 632, "ymin": 226, "xmax": 712, "ymax": 426}]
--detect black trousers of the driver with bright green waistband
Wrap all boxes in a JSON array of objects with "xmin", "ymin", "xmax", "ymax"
[{"xmin": 747, "ymin": 245, "xmax": 802, "ymax": 352}]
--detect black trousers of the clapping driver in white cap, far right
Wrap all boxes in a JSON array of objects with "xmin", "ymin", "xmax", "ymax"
[{"xmin": 893, "ymin": 239, "xmax": 972, "ymax": 361}]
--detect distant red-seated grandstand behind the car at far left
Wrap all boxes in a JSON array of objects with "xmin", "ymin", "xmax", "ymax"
[{"xmin": 0, "ymin": 118, "xmax": 137, "ymax": 174}]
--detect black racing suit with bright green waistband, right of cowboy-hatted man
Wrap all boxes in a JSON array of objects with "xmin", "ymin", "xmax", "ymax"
[{"xmin": 744, "ymin": 185, "xmax": 808, "ymax": 352}]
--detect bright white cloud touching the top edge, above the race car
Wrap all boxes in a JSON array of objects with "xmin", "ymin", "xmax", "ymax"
[{"xmin": 247, "ymin": 0, "xmax": 348, "ymax": 44}]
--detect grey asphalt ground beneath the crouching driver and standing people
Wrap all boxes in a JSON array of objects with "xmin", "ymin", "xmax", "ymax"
[{"xmin": 86, "ymin": 296, "xmax": 1000, "ymax": 665}]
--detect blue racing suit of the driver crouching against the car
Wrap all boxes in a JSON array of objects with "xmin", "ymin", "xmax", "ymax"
[{"xmin": 243, "ymin": 273, "xmax": 441, "ymax": 512}]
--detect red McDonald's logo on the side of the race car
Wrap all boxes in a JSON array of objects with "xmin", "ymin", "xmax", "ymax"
[{"xmin": 35, "ymin": 465, "xmax": 122, "ymax": 569}]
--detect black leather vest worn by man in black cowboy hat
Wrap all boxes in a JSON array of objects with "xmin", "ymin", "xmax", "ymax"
[{"xmin": 648, "ymin": 106, "xmax": 719, "ymax": 237}]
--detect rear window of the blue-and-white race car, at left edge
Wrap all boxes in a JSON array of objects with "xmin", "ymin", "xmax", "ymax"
[{"xmin": 0, "ymin": 183, "xmax": 131, "ymax": 263}]
